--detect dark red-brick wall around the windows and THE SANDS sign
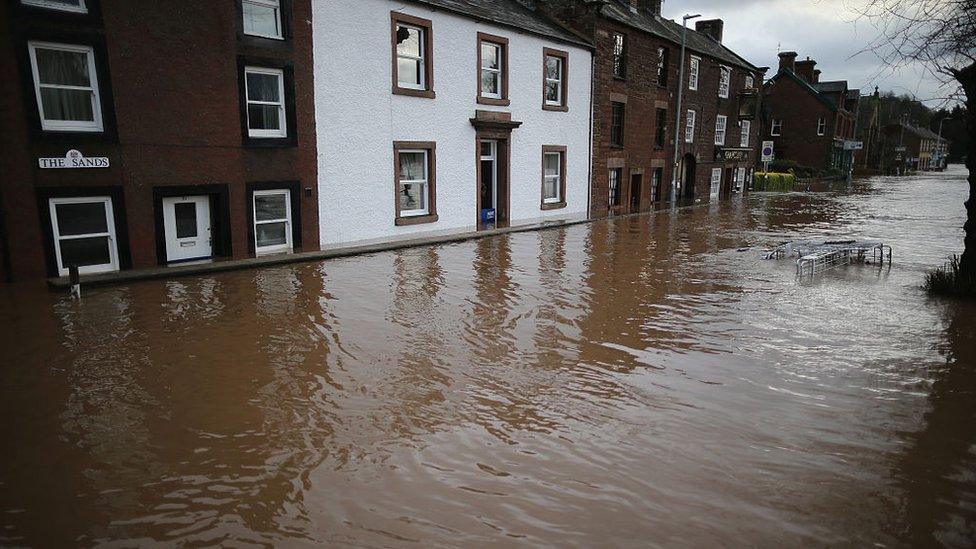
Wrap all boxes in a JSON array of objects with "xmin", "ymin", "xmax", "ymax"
[{"xmin": 0, "ymin": 0, "xmax": 319, "ymax": 279}]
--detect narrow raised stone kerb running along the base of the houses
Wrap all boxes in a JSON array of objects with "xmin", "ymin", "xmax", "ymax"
[{"xmin": 47, "ymin": 202, "xmax": 708, "ymax": 290}]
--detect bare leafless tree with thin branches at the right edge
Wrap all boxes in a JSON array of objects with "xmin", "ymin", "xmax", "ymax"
[{"xmin": 858, "ymin": 0, "xmax": 976, "ymax": 280}]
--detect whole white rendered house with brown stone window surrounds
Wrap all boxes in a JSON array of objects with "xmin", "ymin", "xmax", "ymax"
[{"xmin": 312, "ymin": 0, "xmax": 592, "ymax": 249}]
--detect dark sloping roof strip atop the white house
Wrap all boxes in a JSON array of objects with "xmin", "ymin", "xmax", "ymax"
[{"xmin": 402, "ymin": 0, "xmax": 592, "ymax": 48}]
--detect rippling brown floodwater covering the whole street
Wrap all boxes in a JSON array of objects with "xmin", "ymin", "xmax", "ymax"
[{"xmin": 0, "ymin": 168, "xmax": 976, "ymax": 547}]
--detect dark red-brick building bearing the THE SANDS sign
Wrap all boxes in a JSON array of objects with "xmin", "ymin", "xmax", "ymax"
[{"xmin": 0, "ymin": 0, "xmax": 319, "ymax": 280}]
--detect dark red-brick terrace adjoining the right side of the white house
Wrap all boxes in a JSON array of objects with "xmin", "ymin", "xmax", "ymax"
[{"xmin": 535, "ymin": 0, "xmax": 763, "ymax": 217}]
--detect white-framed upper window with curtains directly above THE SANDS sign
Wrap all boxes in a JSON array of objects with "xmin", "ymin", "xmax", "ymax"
[{"xmin": 28, "ymin": 42, "xmax": 103, "ymax": 132}]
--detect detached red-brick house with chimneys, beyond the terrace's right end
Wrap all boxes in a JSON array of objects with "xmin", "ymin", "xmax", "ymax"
[{"xmin": 763, "ymin": 52, "xmax": 861, "ymax": 171}]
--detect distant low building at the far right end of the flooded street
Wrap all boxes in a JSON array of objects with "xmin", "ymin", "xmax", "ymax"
[{"xmin": 881, "ymin": 123, "xmax": 949, "ymax": 173}]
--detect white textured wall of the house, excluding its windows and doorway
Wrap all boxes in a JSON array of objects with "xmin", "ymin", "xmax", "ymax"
[{"xmin": 312, "ymin": 0, "xmax": 592, "ymax": 248}]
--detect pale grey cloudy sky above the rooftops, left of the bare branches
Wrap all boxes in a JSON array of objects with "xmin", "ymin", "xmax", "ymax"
[{"xmin": 663, "ymin": 0, "xmax": 946, "ymax": 107}]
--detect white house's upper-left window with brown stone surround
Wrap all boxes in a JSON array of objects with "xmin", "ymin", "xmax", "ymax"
[{"xmin": 391, "ymin": 12, "xmax": 434, "ymax": 98}]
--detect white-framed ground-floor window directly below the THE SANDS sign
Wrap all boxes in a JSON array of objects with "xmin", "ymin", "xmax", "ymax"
[{"xmin": 50, "ymin": 196, "xmax": 119, "ymax": 276}]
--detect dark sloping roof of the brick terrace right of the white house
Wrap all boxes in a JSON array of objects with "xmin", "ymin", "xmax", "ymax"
[{"xmin": 603, "ymin": 0, "xmax": 759, "ymax": 71}]
